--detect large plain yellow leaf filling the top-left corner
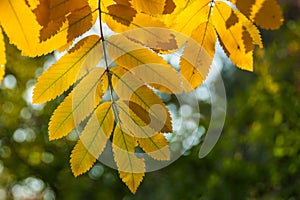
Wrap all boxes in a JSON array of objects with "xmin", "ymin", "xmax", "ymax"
[{"xmin": 0, "ymin": 0, "xmax": 40, "ymax": 55}]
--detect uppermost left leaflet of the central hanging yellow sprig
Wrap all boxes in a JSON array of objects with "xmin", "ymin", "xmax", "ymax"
[{"xmin": 33, "ymin": 35, "xmax": 102, "ymax": 103}]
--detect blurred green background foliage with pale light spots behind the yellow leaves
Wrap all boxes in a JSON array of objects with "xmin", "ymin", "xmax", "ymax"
[{"xmin": 0, "ymin": 4, "xmax": 300, "ymax": 200}]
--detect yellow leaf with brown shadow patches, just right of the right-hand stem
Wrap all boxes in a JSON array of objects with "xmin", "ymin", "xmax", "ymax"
[{"xmin": 211, "ymin": 2, "xmax": 262, "ymax": 71}]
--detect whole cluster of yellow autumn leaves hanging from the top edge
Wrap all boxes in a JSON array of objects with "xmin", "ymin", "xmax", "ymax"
[{"xmin": 0, "ymin": 0, "xmax": 283, "ymax": 193}]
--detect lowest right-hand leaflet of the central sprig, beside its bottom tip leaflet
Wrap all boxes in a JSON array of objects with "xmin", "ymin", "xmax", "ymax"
[{"xmin": 117, "ymin": 101, "xmax": 170, "ymax": 160}]
